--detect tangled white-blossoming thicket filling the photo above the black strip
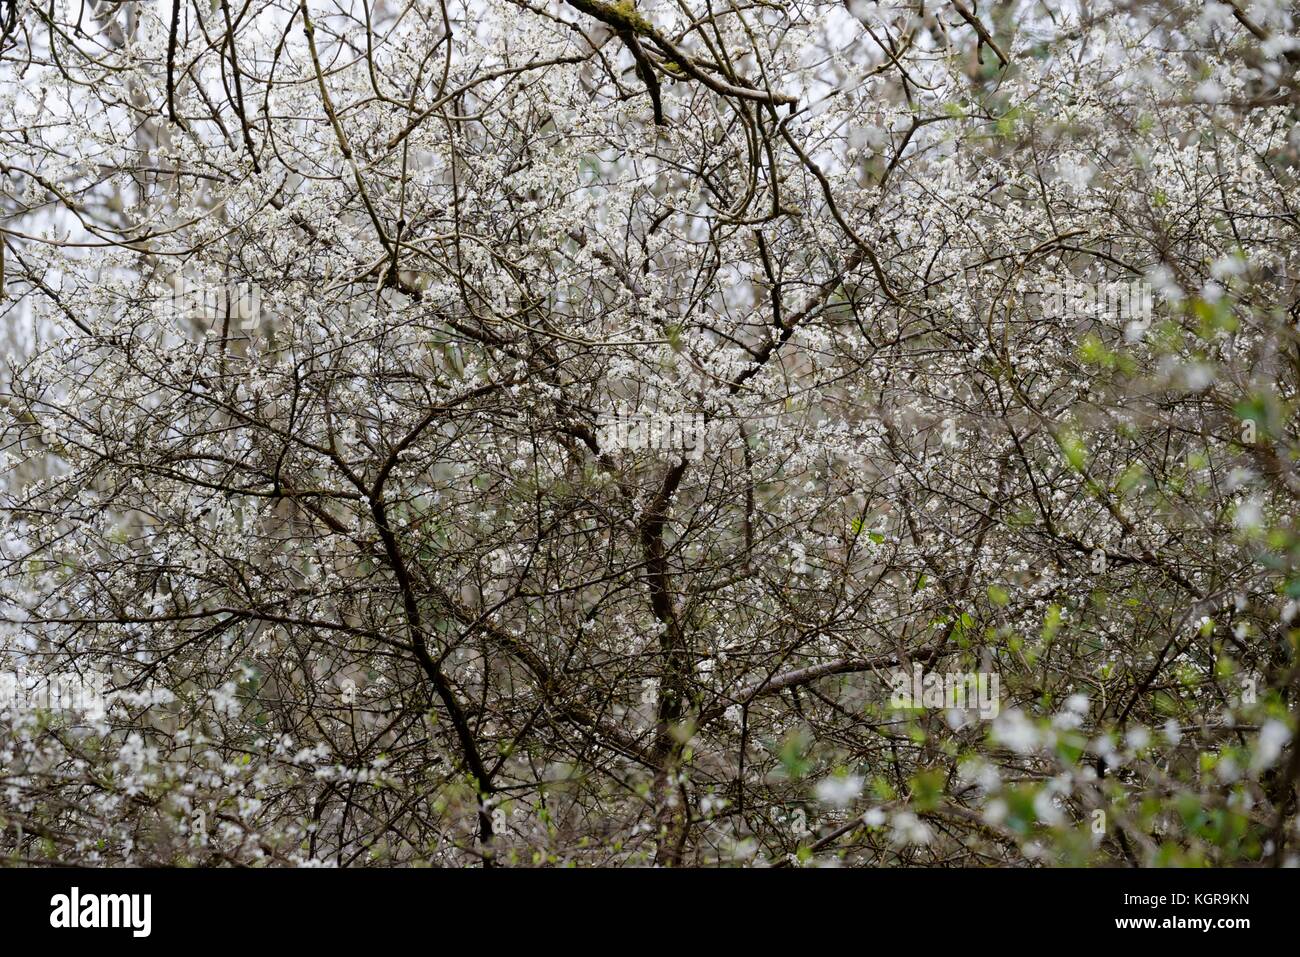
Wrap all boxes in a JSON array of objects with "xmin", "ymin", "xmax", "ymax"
[{"xmin": 0, "ymin": 0, "xmax": 1300, "ymax": 866}]
